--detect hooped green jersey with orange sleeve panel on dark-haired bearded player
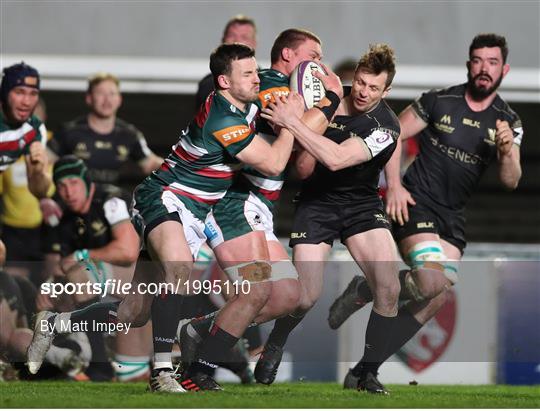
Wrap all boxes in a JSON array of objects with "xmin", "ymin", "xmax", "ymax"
[{"xmin": 150, "ymin": 92, "xmax": 258, "ymax": 207}]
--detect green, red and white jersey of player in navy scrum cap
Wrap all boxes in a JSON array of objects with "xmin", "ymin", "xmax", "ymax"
[{"xmin": 0, "ymin": 111, "xmax": 47, "ymax": 172}]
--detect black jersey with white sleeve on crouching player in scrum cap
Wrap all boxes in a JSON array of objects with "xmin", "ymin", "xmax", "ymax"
[{"xmin": 43, "ymin": 184, "xmax": 129, "ymax": 257}]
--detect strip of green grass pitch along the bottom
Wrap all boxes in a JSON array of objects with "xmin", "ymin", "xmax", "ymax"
[{"xmin": 0, "ymin": 381, "xmax": 540, "ymax": 408}]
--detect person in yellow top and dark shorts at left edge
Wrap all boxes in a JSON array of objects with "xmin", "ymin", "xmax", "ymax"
[{"xmin": 0, "ymin": 98, "xmax": 54, "ymax": 286}]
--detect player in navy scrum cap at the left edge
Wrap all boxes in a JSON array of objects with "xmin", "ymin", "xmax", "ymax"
[{"xmin": 0, "ymin": 62, "xmax": 51, "ymax": 198}]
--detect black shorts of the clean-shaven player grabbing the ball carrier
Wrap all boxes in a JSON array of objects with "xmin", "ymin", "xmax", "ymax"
[{"xmin": 289, "ymin": 198, "xmax": 391, "ymax": 247}]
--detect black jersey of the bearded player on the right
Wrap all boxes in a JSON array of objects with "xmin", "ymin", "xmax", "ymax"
[{"xmin": 403, "ymin": 84, "xmax": 523, "ymax": 210}]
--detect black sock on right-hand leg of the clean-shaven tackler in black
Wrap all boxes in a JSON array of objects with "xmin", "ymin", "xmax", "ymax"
[{"xmin": 352, "ymin": 310, "xmax": 396, "ymax": 377}]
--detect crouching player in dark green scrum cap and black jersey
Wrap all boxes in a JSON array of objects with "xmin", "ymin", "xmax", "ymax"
[{"xmin": 29, "ymin": 155, "xmax": 143, "ymax": 381}]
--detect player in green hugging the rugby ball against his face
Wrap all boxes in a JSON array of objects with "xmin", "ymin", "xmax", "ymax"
[{"xmin": 178, "ymin": 29, "xmax": 343, "ymax": 390}]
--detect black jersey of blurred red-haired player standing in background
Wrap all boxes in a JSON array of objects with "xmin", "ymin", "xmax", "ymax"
[{"xmin": 49, "ymin": 116, "xmax": 151, "ymax": 184}]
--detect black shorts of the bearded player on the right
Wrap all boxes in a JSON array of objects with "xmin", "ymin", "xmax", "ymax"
[{"xmin": 392, "ymin": 194, "xmax": 467, "ymax": 255}]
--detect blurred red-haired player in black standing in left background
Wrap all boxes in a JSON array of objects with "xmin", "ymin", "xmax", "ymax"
[{"xmin": 50, "ymin": 73, "xmax": 163, "ymax": 196}]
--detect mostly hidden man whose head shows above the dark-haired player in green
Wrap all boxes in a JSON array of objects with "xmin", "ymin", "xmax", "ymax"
[{"xmin": 195, "ymin": 14, "xmax": 257, "ymax": 110}]
